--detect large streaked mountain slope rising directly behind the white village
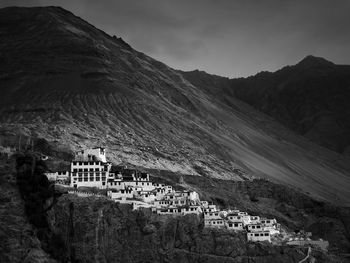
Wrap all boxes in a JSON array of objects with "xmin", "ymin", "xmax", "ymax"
[{"xmin": 0, "ymin": 7, "xmax": 350, "ymax": 205}]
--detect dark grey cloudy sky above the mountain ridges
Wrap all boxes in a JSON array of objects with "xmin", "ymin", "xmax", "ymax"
[{"xmin": 0, "ymin": 0, "xmax": 350, "ymax": 77}]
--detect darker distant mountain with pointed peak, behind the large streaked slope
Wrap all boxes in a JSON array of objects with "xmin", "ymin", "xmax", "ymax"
[{"xmin": 183, "ymin": 56, "xmax": 350, "ymax": 155}]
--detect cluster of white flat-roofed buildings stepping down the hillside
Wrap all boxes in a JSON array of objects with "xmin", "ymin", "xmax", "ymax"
[{"xmin": 46, "ymin": 147, "xmax": 329, "ymax": 250}]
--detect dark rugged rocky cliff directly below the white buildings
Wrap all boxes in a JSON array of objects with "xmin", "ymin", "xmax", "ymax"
[{"xmin": 48, "ymin": 195, "xmax": 338, "ymax": 263}]
